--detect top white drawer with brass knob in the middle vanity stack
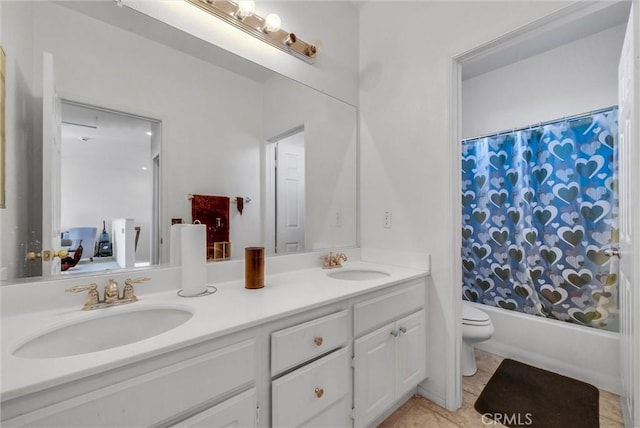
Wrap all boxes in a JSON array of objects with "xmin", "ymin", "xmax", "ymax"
[{"xmin": 271, "ymin": 311, "xmax": 348, "ymax": 376}]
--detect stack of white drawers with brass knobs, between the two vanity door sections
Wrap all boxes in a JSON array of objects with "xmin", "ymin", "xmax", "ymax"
[{"xmin": 271, "ymin": 311, "xmax": 351, "ymax": 427}]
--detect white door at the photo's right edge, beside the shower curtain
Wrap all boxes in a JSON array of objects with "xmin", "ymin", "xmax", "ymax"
[{"xmin": 618, "ymin": 2, "xmax": 640, "ymax": 426}]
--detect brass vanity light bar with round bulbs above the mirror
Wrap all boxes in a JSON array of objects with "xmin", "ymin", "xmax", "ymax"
[{"xmin": 186, "ymin": 0, "xmax": 317, "ymax": 64}]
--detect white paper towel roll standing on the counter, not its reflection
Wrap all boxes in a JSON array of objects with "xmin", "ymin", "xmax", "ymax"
[{"xmin": 180, "ymin": 224, "xmax": 207, "ymax": 297}]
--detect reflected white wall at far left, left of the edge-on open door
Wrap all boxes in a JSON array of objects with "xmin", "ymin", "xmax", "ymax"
[{"xmin": 0, "ymin": 1, "xmax": 36, "ymax": 278}]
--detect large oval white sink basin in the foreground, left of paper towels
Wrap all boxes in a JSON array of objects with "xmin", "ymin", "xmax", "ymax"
[{"xmin": 13, "ymin": 308, "xmax": 193, "ymax": 358}]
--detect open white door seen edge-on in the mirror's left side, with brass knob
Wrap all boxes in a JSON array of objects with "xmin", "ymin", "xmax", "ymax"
[{"xmin": 42, "ymin": 52, "xmax": 62, "ymax": 276}]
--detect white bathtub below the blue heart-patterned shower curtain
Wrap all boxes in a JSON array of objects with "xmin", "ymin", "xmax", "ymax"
[{"xmin": 473, "ymin": 303, "xmax": 622, "ymax": 394}]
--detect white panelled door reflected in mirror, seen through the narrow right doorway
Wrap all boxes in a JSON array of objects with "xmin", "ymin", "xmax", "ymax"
[{"xmin": 276, "ymin": 132, "xmax": 305, "ymax": 254}]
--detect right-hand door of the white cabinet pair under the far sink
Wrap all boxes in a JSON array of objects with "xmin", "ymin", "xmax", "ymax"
[{"xmin": 396, "ymin": 310, "xmax": 427, "ymax": 397}]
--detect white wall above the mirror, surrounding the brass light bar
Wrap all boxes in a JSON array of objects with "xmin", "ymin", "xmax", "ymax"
[{"xmin": 123, "ymin": 0, "xmax": 359, "ymax": 105}]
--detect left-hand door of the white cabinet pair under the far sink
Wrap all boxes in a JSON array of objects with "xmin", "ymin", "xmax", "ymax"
[{"xmin": 353, "ymin": 323, "xmax": 397, "ymax": 426}]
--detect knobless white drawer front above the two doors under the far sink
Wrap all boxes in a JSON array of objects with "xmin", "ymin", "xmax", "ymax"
[{"xmin": 353, "ymin": 279, "xmax": 425, "ymax": 337}]
